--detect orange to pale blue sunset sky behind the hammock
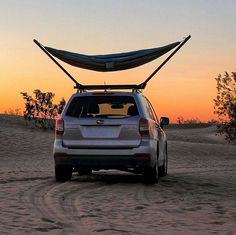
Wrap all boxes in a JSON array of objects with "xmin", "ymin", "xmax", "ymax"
[{"xmin": 0, "ymin": 0, "xmax": 236, "ymax": 121}]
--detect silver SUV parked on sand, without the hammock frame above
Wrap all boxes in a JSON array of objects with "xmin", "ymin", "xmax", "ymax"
[{"xmin": 53, "ymin": 90, "xmax": 169, "ymax": 183}]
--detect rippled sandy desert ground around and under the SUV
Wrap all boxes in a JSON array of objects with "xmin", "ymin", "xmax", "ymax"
[{"xmin": 0, "ymin": 116, "xmax": 236, "ymax": 235}]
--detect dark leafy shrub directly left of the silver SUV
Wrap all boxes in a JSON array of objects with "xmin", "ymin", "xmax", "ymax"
[{"xmin": 21, "ymin": 89, "xmax": 65, "ymax": 129}]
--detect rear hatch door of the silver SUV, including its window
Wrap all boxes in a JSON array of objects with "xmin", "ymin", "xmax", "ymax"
[{"xmin": 63, "ymin": 96, "xmax": 141, "ymax": 149}]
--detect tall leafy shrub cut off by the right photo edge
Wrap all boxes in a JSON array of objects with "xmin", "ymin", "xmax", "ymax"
[{"xmin": 214, "ymin": 72, "xmax": 236, "ymax": 141}]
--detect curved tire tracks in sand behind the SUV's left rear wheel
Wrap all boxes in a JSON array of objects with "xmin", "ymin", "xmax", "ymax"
[{"xmin": 21, "ymin": 177, "xmax": 97, "ymax": 234}]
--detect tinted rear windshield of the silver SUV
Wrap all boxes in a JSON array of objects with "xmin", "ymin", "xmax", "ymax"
[{"xmin": 66, "ymin": 96, "xmax": 138, "ymax": 118}]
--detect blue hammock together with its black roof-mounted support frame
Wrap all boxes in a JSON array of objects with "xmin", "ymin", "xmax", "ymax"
[{"xmin": 34, "ymin": 35, "xmax": 191, "ymax": 91}]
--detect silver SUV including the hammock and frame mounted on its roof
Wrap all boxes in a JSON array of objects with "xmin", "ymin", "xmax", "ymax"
[{"xmin": 34, "ymin": 35, "xmax": 191, "ymax": 183}]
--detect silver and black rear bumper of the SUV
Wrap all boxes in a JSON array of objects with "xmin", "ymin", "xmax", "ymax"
[{"xmin": 53, "ymin": 140, "xmax": 154, "ymax": 169}]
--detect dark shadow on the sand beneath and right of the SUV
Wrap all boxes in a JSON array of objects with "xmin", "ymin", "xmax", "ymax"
[{"xmin": 67, "ymin": 171, "xmax": 226, "ymax": 195}]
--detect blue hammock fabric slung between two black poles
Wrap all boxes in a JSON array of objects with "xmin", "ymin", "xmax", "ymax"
[{"xmin": 44, "ymin": 42, "xmax": 180, "ymax": 72}]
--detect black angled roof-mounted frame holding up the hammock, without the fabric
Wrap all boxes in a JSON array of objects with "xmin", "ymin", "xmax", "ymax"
[{"xmin": 33, "ymin": 35, "xmax": 191, "ymax": 91}]
